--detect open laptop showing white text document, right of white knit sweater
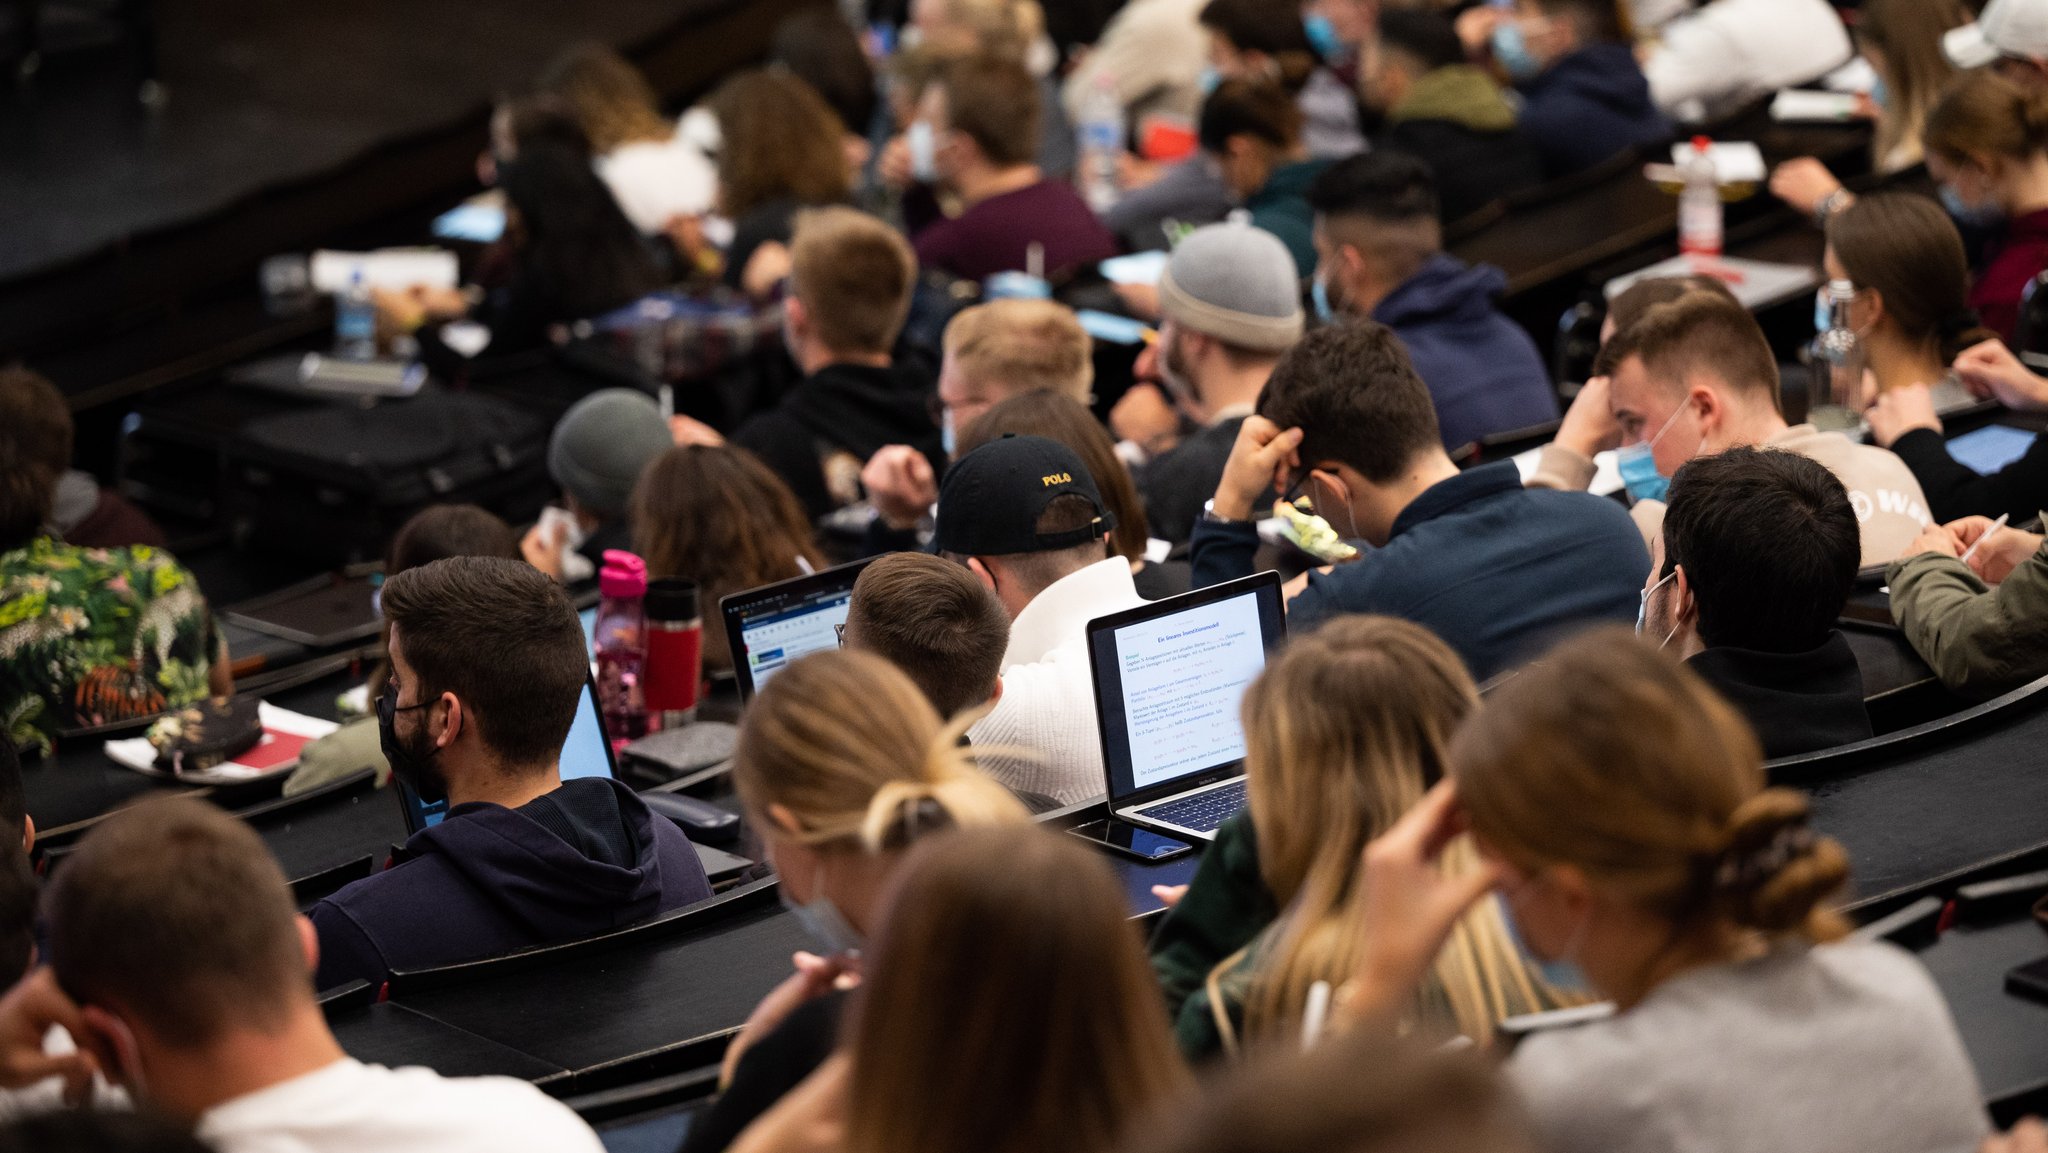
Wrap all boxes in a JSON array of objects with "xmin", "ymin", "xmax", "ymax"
[{"xmin": 1087, "ymin": 571, "xmax": 1286, "ymax": 840}]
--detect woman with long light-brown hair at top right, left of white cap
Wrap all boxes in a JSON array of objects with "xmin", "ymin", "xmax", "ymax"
[{"xmin": 1772, "ymin": 0, "xmax": 1970, "ymax": 225}]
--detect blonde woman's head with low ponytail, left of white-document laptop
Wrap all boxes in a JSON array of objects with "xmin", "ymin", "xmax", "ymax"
[{"xmin": 733, "ymin": 649, "xmax": 1026, "ymax": 928}]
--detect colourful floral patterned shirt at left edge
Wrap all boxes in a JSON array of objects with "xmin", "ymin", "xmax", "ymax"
[{"xmin": 0, "ymin": 537, "xmax": 227, "ymax": 752}]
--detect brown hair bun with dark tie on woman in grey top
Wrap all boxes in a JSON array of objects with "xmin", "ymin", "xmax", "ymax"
[{"xmin": 1712, "ymin": 788, "xmax": 1849, "ymax": 934}]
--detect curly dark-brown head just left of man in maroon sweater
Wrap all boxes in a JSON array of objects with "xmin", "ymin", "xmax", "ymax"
[{"xmin": 709, "ymin": 68, "xmax": 858, "ymax": 219}]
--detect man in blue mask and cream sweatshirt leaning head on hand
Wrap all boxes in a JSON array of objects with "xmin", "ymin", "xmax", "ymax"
[{"xmin": 1534, "ymin": 293, "xmax": 1929, "ymax": 567}]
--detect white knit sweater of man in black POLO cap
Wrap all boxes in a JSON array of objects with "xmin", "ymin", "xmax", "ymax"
[{"xmin": 969, "ymin": 557, "xmax": 1145, "ymax": 805}]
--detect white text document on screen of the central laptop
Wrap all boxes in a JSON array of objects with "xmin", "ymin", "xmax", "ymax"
[{"xmin": 1114, "ymin": 592, "xmax": 1266, "ymax": 788}]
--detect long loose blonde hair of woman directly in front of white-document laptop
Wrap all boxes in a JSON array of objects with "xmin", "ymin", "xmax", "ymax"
[{"xmin": 1243, "ymin": 616, "xmax": 1536, "ymax": 1040}]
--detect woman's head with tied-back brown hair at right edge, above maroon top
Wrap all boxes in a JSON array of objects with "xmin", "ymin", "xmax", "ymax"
[{"xmin": 1921, "ymin": 70, "xmax": 2048, "ymax": 217}]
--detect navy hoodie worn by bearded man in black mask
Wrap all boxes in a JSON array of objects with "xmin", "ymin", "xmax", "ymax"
[{"xmin": 311, "ymin": 778, "xmax": 711, "ymax": 989}]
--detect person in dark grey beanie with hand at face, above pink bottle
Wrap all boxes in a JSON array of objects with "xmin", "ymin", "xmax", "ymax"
[{"xmin": 520, "ymin": 389, "xmax": 674, "ymax": 584}]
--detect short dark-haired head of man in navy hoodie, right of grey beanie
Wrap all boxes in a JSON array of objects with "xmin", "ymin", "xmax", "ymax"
[{"xmin": 1309, "ymin": 150, "xmax": 1444, "ymax": 315}]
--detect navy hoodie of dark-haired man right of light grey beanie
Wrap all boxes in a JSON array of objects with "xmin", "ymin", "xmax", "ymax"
[{"xmin": 1372, "ymin": 252, "xmax": 1556, "ymax": 449}]
